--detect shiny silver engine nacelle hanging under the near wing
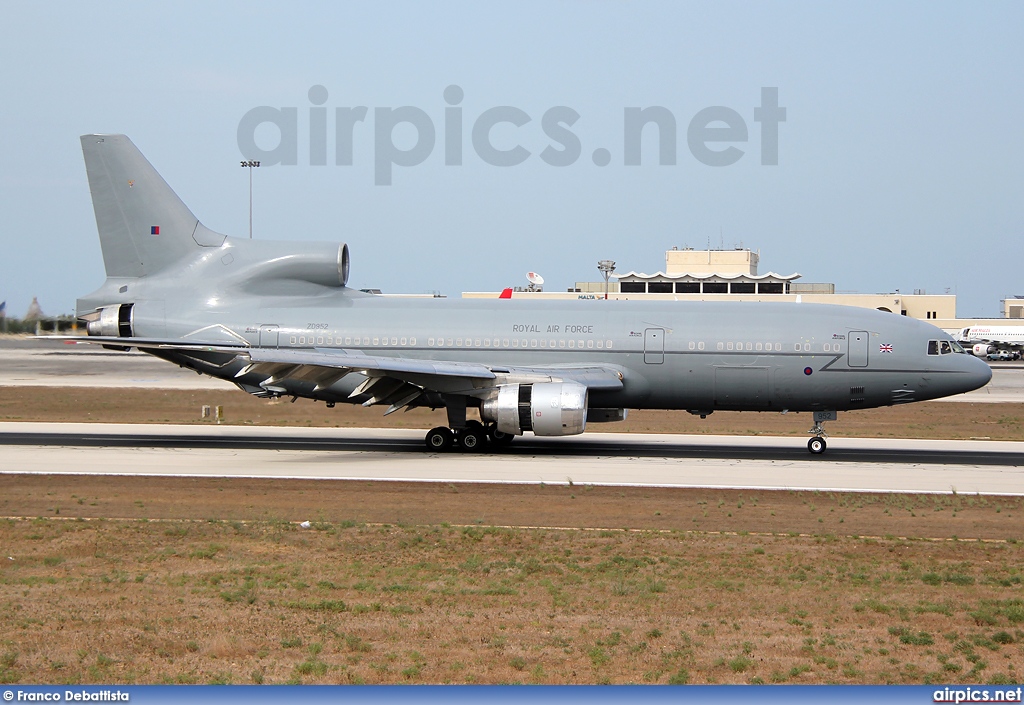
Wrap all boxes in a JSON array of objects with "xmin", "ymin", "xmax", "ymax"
[{"xmin": 480, "ymin": 382, "xmax": 587, "ymax": 436}]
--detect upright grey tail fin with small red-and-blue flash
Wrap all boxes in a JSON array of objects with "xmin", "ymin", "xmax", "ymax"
[{"xmin": 82, "ymin": 134, "xmax": 224, "ymax": 277}]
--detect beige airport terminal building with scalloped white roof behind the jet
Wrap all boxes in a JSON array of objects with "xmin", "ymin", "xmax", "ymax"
[{"xmin": 463, "ymin": 247, "xmax": 1024, "ymax": 332}]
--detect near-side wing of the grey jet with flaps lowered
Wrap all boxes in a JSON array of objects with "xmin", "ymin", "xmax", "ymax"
[{"xmin": 41, "ymin": 336, "xmax": 623, "ymax": 414}]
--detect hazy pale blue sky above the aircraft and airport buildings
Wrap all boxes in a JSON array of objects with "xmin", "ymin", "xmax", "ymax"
[{"xmin": 0, "ymin": 0, "xmax": 1024, "ymax": 317}]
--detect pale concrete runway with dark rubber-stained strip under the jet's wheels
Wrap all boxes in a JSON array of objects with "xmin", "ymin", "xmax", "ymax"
[{"xmin": 0, "ymin": 423, "xmax": 1024, "ymax": 495}]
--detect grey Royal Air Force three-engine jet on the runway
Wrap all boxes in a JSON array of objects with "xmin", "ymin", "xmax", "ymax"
[{"xmin": 59, "ymin": 134, "xmax": 991, "ymax": 453}]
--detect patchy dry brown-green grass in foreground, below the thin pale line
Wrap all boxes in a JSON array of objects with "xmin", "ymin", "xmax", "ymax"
[{"xmin": 0, "ymin": 512, "xmax": 1024, "ymax": 683}]
